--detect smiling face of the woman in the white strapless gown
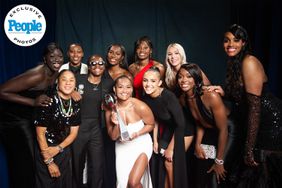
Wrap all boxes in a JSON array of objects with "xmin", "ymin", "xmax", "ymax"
[{"xmin": 114, "ymin": 76, "xmax": 133, "ymax": 101}]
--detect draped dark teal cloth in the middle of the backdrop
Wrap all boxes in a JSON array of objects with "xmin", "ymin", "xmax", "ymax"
[{"xmin": 56, "ymin": 0, "xmax": 230, "ymax": 84}]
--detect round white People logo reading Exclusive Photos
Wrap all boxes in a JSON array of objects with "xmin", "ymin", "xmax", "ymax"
[{"xmin": 4, "ymin": 4, "xmax": 46, "ymax": 46}]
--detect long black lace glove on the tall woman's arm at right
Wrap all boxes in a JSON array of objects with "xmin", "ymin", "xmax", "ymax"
[{"xmin": 244, "ymin": 93, "xmax": 261, "ymax": 166}]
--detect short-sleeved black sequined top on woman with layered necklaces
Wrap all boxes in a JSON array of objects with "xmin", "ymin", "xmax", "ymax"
[{"xmin": 34, "ymin": 94, "xmax": 81, "ymax": 145}]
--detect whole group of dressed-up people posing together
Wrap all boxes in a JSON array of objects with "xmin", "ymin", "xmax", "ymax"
[{"xmin": 0, "ymin": 24, "xmax": 282, "ymax": 188}]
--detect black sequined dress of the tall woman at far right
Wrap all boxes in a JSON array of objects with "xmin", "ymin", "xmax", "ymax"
[{"xmin": 228, "ymin": 84, "xmax": 282, "ymax": 188}]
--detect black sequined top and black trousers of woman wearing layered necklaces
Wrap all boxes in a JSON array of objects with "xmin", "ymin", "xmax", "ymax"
[{"xmin": 34, "ymin": 94, "xmax": 81, "ymax": 188}]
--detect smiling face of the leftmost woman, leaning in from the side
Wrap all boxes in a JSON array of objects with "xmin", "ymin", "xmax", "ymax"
[{"xmin": 44, "ymin": 49, "xmax": 64, "ymax": 72}]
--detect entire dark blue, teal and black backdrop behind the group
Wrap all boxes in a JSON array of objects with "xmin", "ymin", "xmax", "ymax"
[{"xmin": 0, "ymin": 0, "xmax": 282, "ymax": 187}]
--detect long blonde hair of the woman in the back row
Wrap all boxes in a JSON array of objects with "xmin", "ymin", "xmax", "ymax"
[{"xmin": 165, "ymin": 43, "xmax": 187, "ymax": 89}]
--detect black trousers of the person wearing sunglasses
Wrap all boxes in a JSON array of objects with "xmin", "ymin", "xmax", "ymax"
[{"xmin": 72, "ymin": 119, "xmax": 105, "ymax": 188}]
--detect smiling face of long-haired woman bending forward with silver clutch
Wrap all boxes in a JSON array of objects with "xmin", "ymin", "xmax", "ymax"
[{"xmin": 177, "ymin": 68, "xmax": 195, "ymax": 93}]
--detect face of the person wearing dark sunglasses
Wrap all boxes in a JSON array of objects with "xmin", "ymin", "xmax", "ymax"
[{"xmin": 88, "ymin": 55, "xmax": 105, "ymax": 76}]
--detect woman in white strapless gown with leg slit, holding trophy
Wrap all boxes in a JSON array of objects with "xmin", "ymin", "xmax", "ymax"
[{"xmin": 105, "ymin": 75, "xmax": 155, "ymax": 188}]
